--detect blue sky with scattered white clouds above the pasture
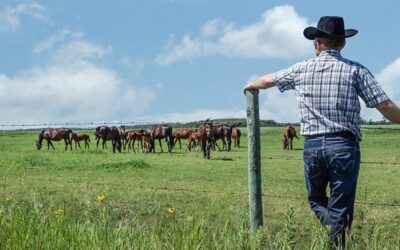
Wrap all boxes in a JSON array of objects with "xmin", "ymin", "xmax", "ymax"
[{"xmin": 0, "ymin": 0, "xmax": 400, "ymax": 127}]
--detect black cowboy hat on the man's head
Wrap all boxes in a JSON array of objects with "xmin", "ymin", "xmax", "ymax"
[{"xmin": 303, "ymin": 16, "xmax": 358, "ymax": 40}]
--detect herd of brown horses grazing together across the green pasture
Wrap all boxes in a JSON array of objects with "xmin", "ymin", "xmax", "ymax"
[{"xmin": 36, "ymin": 120, "xmax": 298, "ymax": 159}]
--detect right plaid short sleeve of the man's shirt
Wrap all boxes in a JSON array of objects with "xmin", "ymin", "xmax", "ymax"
[{"xmin": 356, "ymin": 68, "xmax": 389, "ymax": 108}]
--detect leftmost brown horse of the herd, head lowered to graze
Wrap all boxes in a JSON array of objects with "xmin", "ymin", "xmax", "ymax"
[{"xmin": 36, "ymin": 128, "xmax": 72, "ymax": 150}]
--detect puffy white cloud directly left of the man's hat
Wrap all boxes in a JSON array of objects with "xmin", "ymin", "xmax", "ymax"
[{"xmin": 155, "ymin": 5, "xmax": 312, "ymax": 65}]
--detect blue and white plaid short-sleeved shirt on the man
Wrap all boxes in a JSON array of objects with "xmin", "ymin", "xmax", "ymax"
[{"xmin": 272, "ymin": 50, "xmax": 389, "ymax": 141}]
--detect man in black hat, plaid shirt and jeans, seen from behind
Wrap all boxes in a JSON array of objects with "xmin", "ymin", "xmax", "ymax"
[{"xmin": 243, "ymin": 16, "xmax": 400, "ymax": 247}]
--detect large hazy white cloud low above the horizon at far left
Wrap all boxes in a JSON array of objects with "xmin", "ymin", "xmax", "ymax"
[{"xmin": 0, "ymin": 31, "xmax": 156, "ymax": 123}]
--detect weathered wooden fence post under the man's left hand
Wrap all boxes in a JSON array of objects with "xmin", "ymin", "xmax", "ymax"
[{"xmin": 246, "ymin": 90, "xmax": 263, "ymax": 233}]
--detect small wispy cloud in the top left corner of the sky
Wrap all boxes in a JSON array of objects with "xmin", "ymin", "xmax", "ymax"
[{"xmin": 0, "ymin": 2, "xmax": 47, "ymax": 33}]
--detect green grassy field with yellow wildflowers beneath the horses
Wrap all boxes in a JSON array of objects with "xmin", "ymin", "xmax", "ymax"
[{"xmin": 0, "ymin": 126, "xmax": 400, "ymax": 249}]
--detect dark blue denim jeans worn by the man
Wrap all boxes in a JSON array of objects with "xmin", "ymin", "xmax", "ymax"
[{"xmin": 303, "ymin": 134, "xmax": 360, "ymax": 246}]
